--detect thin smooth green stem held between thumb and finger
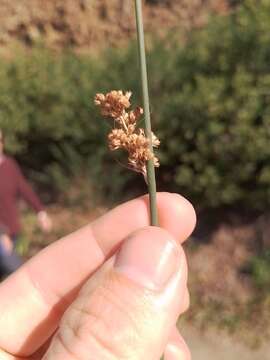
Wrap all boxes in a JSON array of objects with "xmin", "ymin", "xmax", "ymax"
[{"xmin": 135, "ymin": 0, "xmax": 158, "ymax": 226}]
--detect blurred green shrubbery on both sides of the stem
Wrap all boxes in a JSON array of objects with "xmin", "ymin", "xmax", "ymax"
[{"xmin": 0, "ymin": 0, "xmax": 270, "ymax": 209}]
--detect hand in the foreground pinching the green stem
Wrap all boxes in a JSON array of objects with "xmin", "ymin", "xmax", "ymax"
[{"xmin": 0, "ymin": 193, "xmax": 195, "ymax": 360}]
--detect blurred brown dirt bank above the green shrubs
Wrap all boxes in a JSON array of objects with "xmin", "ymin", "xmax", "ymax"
[{"xmin": 0, "ymin": 0, "xmax": 228, "ymax": 52}]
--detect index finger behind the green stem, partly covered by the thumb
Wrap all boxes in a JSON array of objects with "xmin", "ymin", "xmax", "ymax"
[{"xmin": 0, "ymin": 193, "xmax": 195, "ymax": 356}]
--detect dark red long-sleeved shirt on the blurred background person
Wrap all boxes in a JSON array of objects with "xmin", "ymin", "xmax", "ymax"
[{"xmin": 0, "ymin": 157, "xmax": 43, "ymax": 236}]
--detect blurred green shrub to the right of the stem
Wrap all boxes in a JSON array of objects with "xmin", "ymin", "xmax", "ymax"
[{"xmin": 152, "ymin": 1, "xmax": 270, "ymax": 208}]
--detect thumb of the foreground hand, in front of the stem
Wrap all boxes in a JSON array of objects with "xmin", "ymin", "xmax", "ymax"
[{"xmin": 44, "ymin": 227, "xmax": 187, "ymax": 360}]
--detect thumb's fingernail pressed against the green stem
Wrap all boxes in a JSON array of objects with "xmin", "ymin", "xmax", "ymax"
[{"xmin": 115, "ymin": 227, "xmax": 181, "ymax": 290}]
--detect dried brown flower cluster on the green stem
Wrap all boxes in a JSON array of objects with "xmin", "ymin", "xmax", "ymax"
[{"xmin": 95, "ymin": 90, "xmax": 160, "ymax": 177}]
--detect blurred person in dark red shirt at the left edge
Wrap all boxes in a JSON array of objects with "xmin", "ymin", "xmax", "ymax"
[{"xmin": 0, "ymin": 129, "xmax": 52, "ymax": 275}]
